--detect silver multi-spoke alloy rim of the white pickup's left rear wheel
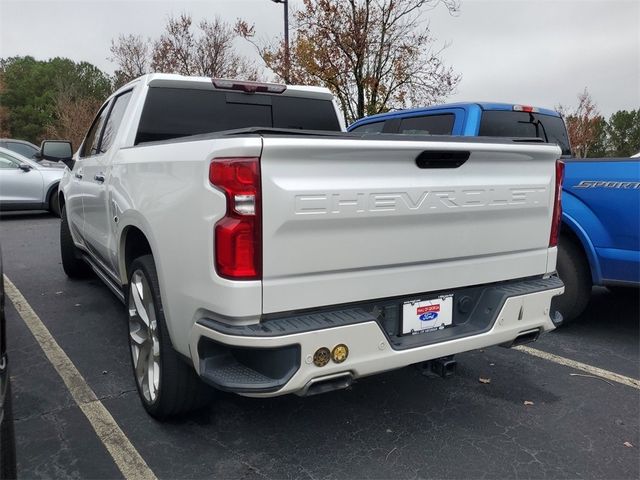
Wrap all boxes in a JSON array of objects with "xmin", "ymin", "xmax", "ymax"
[{"xmin": 129, "ymin": 270, "xmax": 160, "ymax": 403}]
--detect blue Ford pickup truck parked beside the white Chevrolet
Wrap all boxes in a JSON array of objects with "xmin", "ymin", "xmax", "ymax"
[{"xmin": 348, "ymin": 103, "xmax": 640, "ymax": 320}]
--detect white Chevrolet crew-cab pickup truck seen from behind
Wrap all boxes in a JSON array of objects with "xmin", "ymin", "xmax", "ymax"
[{"xmin": 41, "ymin": 74, "xmax": 563, "ymax": 418}]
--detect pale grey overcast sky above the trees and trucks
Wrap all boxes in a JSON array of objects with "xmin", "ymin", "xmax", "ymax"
[{"xmin": 0, "ymin": 0, "xmax": 640, "ymax": 116}]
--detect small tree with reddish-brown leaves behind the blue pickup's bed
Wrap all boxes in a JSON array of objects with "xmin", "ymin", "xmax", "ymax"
[{"xmin": 557, "ymin": 87, "xmax": 603, "ymax": 158}]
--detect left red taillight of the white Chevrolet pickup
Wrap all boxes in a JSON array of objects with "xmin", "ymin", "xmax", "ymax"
[{"xmin": 209, "ymin": 157, "xmax": 262, "ymax": 280}]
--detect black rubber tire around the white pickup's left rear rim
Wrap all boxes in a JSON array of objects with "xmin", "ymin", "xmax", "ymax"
[{"xmin": 127, "ymin": 255, "xmax": 212, "ymax": 420}]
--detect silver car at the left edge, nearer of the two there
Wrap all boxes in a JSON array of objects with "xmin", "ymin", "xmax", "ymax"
[{"xmin": 0, "ymin": 147, "xmax": 64, "ymax": 216}]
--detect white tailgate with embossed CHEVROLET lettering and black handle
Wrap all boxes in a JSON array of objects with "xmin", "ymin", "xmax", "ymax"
[{"xmin": 261, "ymin": 135, "xmax": 560, "ymax": 313}]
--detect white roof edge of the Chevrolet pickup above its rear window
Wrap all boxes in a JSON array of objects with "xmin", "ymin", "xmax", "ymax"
[{"xmin": 116, "ymin": 73, "xmax": 333, "ymax": 100}]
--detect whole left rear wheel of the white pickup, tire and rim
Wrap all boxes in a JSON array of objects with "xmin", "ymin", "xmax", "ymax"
[{"xmin": 127, "ymin": 255, "xmax": 210, "ymax": 419}]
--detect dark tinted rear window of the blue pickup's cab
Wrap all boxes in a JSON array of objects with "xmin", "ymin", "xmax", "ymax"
[{"xmin": 478, "ymin": 110, "xmax": 571, "ymax": 155}]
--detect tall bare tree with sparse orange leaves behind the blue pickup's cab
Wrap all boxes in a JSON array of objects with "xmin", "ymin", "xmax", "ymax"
[{"xmin": 236, "ymin": 0, "xmax": 460, "ymax": 121}]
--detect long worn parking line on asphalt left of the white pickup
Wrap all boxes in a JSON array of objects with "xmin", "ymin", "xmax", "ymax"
[{"xmin": 4, "ymin": 275, "xmax": 156, "ymax": 480}]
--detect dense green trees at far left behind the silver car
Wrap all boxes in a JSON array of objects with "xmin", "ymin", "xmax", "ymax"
[{"xmin": 0, "ymin": 56, "xmax": 111, "ymax": 143}]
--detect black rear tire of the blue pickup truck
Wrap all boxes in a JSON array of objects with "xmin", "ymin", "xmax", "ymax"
[{"xmin": 551, "ymin": 236, "xmax": 593, "ymax": 322}]
